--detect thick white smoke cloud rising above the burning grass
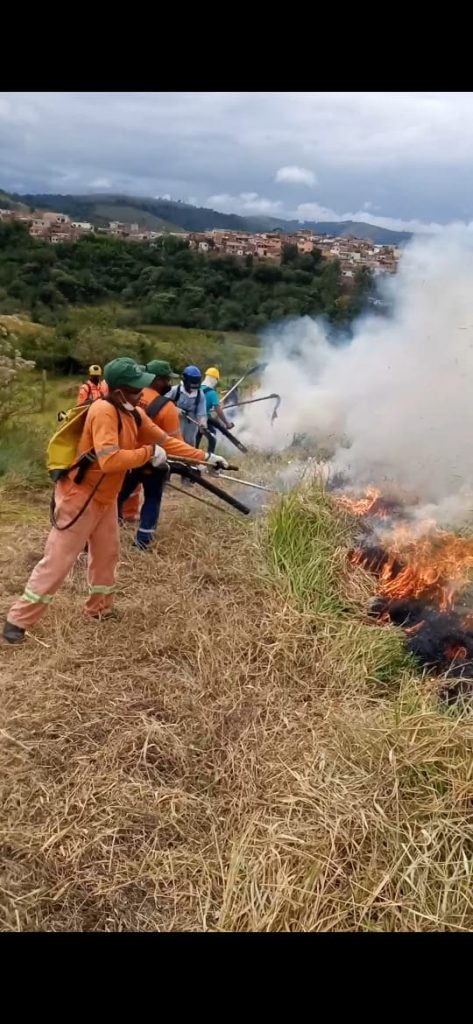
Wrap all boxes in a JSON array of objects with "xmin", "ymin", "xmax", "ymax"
[{"xmin": 239, "ymin": 230, "xmax": 473, "ymax": 522}]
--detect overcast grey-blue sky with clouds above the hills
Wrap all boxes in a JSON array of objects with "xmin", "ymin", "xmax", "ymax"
[{"xmin": 0, "ymin": 92, "xmax": 473, "ymax": 230}]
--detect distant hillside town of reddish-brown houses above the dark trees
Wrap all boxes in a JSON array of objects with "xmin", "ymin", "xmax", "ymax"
[{"xmin": 0, "ymin": 209, "xmax": 400, "ymax": 279}]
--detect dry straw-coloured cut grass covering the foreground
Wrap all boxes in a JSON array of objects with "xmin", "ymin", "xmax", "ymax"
[{"xmin": 0, "ymin": 483, "xmax": 473, "ymax": 931}]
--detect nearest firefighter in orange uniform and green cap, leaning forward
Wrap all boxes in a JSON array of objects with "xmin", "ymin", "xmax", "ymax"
[{"xmin": 3, "ymin": 357, "xmax": 227, "ymax": 644}]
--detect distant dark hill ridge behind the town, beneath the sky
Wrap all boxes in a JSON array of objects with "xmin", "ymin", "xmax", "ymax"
[{"xmin": 10, "ymin": 194, "xmax": 411, "ymax": 245}]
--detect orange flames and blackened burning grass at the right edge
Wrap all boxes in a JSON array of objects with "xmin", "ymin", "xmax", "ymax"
[{"xmin": 337, "ymin": 487, "xmax": 473, "ymax": 702}]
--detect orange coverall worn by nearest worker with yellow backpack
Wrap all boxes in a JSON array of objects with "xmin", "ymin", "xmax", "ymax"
[{"xmin": 7, "ymin": 401, "xmax": 205, "ymax": 629}]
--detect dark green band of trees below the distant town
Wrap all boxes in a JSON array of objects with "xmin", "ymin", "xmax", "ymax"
[{"xmin": 0, "ymin": 223, "xmax": 372, "ymax": 335}]
